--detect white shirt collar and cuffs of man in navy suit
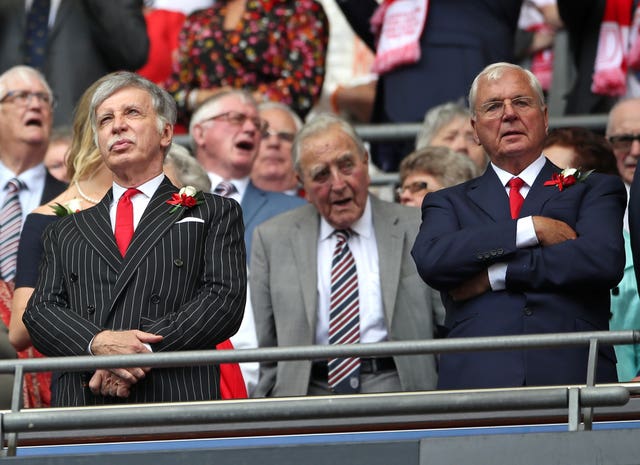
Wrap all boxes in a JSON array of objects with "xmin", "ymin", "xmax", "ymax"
[{"xmin": 488, "ymin": 155, "xmax": 547, "ymax": 291}]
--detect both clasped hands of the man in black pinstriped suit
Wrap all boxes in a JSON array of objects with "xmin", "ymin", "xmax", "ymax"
[{"xmin": 89, "ymin": 329, "xmax": 162, "ymax": 397}]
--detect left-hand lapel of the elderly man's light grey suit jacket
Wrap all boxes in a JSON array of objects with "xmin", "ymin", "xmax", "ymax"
[{"xmin": 291, "ymin": 207, "xmax": 320, "ymax": 337}]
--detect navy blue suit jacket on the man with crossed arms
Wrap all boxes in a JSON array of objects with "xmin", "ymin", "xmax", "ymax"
[{"xmin": 412, "ymin": 161, "xmax": 626, "ymax": 389}]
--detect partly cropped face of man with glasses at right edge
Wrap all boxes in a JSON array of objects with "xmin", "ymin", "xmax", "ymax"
[{"xmin": 607, "ymin": 99, "xmax": 640, "ymax": 184}]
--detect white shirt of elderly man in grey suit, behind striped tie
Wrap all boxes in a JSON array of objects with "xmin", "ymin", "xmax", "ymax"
[{"xmin": 315, "ymin": 198, "xmax": 387, "ymax": 345}]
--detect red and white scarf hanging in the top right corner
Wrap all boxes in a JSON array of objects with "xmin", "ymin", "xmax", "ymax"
[{"xmin": 591, "ymin": 0, "xmax": 640, "ymax": 97}]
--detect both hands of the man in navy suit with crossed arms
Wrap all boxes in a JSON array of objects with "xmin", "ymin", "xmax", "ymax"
[{"xmin": 449, "ymin": 216, "xmax": 578, "ymax": 301}]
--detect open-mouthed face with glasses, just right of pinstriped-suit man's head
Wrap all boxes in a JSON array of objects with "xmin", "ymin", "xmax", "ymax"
[{"xmin": 192, "ymin": 94, "xmax": 261, "ymax": 178}]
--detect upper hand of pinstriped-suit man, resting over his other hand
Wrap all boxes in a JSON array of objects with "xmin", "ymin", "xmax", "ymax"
[{"xmin": 91, "ymin": 329, "xmax": 162, "ymax": 385}]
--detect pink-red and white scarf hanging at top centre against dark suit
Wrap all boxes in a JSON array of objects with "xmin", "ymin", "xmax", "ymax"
[{"xmin": 371, "ymin": 0, "xmax": 429, "ymax": 74}]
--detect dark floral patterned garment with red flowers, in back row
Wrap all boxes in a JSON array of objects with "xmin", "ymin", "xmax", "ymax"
[{"xmin": 165, "ymin": 0, "xmax": 329, "ymax": 122}]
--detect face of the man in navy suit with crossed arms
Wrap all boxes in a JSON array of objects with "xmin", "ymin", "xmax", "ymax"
[{"xmin": 472, "ymin": 69, "xmax": 548, "ymax": 171}]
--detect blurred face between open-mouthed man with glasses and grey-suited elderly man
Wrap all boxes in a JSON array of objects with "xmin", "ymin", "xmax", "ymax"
[{"xmin": 251, "ymin": 108, "xmax": 296, "ymax": 186}]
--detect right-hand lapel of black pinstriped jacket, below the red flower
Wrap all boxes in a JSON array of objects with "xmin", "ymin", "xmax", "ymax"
[{"xmin": 111, "ymin": 178, "xmax": 181, "ymax": 316}]
